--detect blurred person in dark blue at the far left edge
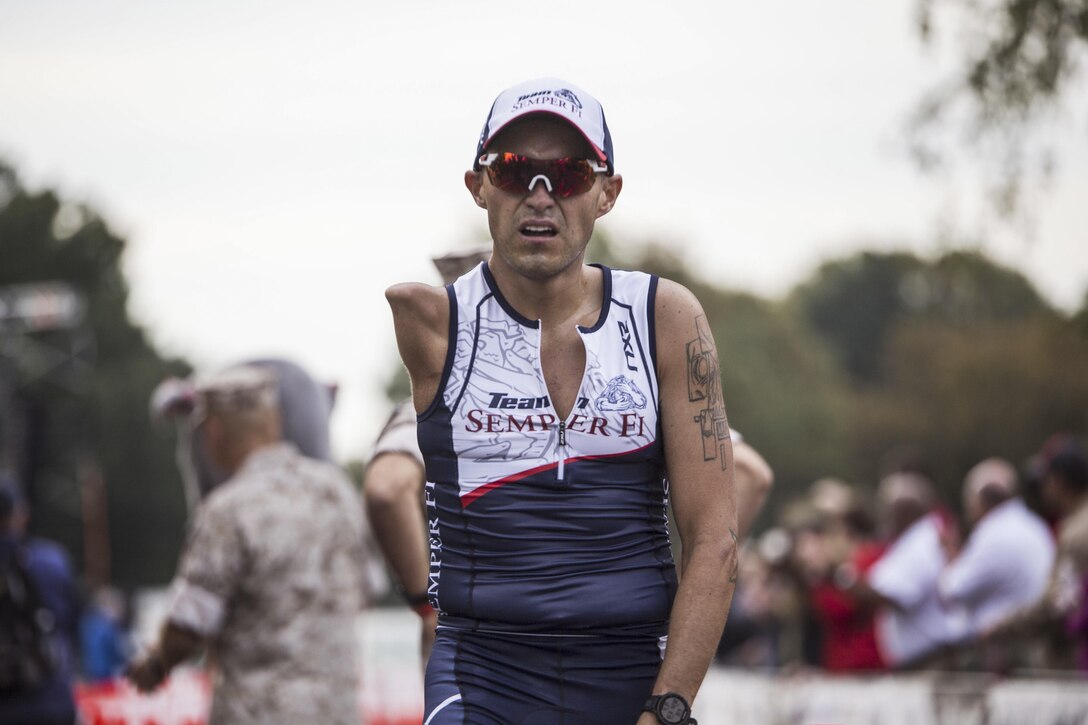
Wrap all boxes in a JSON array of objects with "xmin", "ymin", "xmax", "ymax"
[{"xmin": 0, "ymin": 471, "xmax": 78, "ymax": 725}]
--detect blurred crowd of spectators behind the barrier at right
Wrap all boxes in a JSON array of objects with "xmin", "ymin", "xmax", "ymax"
[{"xmin": 718, "ymin": 434, "xmax": 1088, "ymax": 674}]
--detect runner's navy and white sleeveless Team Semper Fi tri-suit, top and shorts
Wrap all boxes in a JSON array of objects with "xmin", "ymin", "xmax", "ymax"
[{"xmin": 418, "ymin": 263, "xmax": 677, "ymax": 725}]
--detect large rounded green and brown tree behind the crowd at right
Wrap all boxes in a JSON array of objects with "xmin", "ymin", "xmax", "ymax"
[{"xmin": 791, "ymin": 250, "xmax": 1088, "ymax": 502}]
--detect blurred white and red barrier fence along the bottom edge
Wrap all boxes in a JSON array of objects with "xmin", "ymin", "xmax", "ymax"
[{"xmin": 95, "ymin": 610, "xmax": 1088, "ymax": 725}]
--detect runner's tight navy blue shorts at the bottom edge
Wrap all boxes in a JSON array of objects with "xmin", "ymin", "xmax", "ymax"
[{"xmin": 423, "ymin": 628, "xmax": 662, "ymax": 725}]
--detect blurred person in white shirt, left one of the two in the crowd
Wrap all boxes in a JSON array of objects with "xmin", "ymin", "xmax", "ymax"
[{"xmin": 857, "ymin": 472, "xmax": 955, "ymax": 668}]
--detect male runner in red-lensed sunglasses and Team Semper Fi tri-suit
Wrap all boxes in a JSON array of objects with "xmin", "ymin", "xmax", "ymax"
[{"xmin": 386, "ymin": 78, "xmax": 737, "ymax": 725}]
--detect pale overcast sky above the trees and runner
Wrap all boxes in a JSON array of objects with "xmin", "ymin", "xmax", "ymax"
[{"xmin": 0, "ymin": 0, "xmax": 1088, "ymax": 458}]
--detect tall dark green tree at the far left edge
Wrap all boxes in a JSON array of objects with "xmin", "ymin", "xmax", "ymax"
[{"xmin": 0, "ymin": 163, "xmax": 189, "ymax": 585}]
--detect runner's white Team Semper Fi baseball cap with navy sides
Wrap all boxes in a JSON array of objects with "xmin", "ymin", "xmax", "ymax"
[{"xmin": 472, "ymin": 78, "xmax": 616, "ymax": 176}]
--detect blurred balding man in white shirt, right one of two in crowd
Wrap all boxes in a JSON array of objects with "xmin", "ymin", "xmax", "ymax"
[{"xmin": 938, "ymin": 458, "xmax": 1054, "ymax": 637}]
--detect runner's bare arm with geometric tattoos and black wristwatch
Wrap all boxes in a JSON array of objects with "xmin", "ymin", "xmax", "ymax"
[{"xmin": 639, "ymin": 280, "xmax": 738, "ymax": 725}]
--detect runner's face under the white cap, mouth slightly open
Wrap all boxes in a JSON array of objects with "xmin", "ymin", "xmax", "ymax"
[{"xmin": 465, "ymin": 116, "xmax": 622, "ymax": 281}]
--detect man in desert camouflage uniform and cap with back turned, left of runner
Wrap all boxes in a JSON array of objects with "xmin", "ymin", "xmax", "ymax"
[{"xmin": 129, "ymin": 367, "xmax": 363, "ymax": 725}]
